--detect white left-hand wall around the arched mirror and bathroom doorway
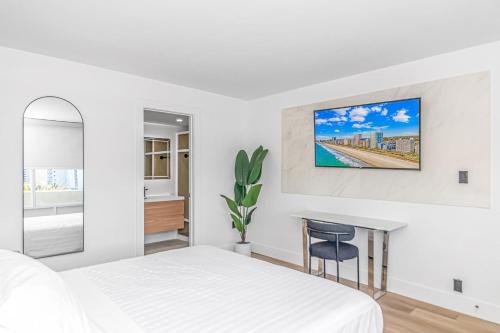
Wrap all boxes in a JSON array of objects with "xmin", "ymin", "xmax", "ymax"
[{"xmin": 0, "ymin": 48, "xmax": 243, "ymax": 270}]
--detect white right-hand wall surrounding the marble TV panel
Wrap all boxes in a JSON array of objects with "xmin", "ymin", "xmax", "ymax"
[{"xmin": 247, "ymin": 43, "xmax": 500, "ymax": 322}]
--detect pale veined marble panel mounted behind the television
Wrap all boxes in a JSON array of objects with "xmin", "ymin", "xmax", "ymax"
[{"xmin": 281, "ymin": 72, "xmax": 491, "ymax": 208}]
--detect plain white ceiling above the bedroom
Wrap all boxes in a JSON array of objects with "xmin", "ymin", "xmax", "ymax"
[{"xmin": 0, "ymin": 0, "xmax": 500, "ymax": 99}]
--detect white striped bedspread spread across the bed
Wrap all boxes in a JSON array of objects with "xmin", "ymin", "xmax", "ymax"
[{"xmin": 61, "ymin": 246, "xmax": 383, "ymax": 333}]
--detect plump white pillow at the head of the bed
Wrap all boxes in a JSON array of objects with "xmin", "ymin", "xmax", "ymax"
[{"xmin": 0, "ymin": 249, "xmax": 93, "ymax": 333}]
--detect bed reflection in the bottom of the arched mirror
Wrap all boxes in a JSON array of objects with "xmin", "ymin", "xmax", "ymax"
[{"xmin": 24, "ymin": 213, "xmax": 83, "ymax": 258}]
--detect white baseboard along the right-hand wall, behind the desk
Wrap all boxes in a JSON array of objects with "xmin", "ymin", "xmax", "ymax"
[{"xmin": 252, "ymin": 242, "xmax": 500, "ymax": 323}]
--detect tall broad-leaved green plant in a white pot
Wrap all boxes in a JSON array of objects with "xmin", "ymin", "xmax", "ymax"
[{"xmin": 221, "ymin": 146, "xmax": 268, "ymax": 256}]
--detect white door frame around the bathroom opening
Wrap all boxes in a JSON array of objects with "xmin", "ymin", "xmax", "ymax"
[{"xmin": 135, "ymin": 105, "xmax": 196, "ymax": 256}]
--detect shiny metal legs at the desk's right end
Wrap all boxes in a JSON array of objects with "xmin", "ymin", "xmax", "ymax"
[{"xmin": 368, "ymin": 230, "xmax": 389, "ymax": 299}]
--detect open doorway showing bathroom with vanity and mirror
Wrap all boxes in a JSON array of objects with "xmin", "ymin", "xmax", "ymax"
[{"xmin": 143, "ymin": 109, "xmax": 193, "ymax": 255}]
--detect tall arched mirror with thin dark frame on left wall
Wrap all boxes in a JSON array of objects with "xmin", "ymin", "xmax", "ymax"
[{"xmin": 23, "ymin": 97, "xmax": 84, "ymax": 258}]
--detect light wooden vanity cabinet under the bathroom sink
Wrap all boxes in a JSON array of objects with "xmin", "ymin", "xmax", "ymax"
[{"xmin": 144, "ymin": 200, "xmax": 184, "ymax": 234}]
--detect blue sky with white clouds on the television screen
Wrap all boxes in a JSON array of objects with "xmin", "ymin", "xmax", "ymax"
[{"xmin": 314, "ymin": 99, "xmax": 420, "ymax": 140}]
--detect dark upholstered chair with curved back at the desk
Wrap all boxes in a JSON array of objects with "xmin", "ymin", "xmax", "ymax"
[{"xmin": 307, "ymin": 220, "xmax": 359, "ymax": 289}]
